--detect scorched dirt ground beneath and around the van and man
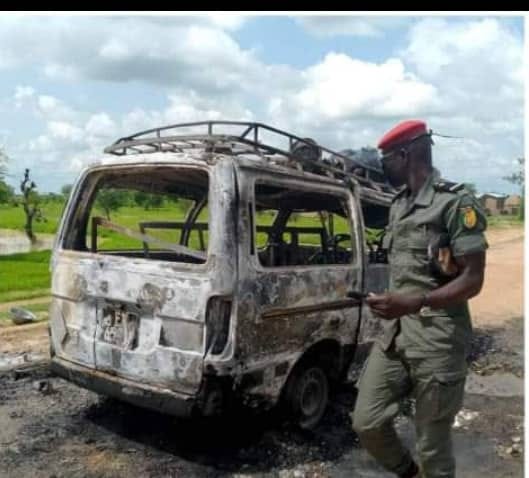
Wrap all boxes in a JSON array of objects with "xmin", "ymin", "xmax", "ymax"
[{"xmin": 0, "ymin": 228, "xmax": 524, "ymax": 478}]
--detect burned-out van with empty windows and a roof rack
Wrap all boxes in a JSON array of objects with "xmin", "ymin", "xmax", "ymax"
[{"xmin": 50, "ymin": 122, "xmax": 392, "ymax": 427}]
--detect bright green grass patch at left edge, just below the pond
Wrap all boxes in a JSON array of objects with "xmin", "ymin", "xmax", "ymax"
[{"xmin": 0, "ymin": 251, "xmax": 51, "ymax": 303}]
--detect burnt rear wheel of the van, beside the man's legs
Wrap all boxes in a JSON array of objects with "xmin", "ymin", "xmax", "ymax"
[{"xmin": 285, "ymin": 363, "xmax": 329, "ymax": 430}]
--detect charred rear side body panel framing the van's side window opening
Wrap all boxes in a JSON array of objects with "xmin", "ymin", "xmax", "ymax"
[{"xmin": 231, "ymin": 166, "xmax": 362, "ymax": 404}]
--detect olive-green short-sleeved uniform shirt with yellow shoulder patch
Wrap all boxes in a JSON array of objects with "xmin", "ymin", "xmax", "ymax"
[{"xmin": 379, "ymin": 170, "xmax": 488, "ymax": 358}]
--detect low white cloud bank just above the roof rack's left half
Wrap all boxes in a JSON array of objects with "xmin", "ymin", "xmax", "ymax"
[{"xmin": 6, "ymin": 83, "xmax": 254, "ymax": 176}]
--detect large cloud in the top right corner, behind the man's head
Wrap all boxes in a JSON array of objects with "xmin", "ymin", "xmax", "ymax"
[{"xmin": 394, "ymin": 18, "xmax": 524, "ymax": 191}]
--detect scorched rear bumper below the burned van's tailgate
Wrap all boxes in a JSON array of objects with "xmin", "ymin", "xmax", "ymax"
[{"xmin": 51, "ymin": 356, "xmax": 195, "ymax": 417}]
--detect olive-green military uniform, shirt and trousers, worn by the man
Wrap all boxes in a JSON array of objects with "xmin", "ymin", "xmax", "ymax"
[{"xmin": 353, "ymin": 170, "xmax": 488, "ymax": 478}]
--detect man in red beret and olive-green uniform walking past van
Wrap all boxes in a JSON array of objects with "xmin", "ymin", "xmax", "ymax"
[{"xmin": 353, "ymin": 120, "xmax": 488, "ymax": 478}]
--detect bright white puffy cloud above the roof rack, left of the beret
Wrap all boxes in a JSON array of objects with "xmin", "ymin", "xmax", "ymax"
[{"xmin": 269, "ymin": 53, "xmax": 438, "ymax": 124}]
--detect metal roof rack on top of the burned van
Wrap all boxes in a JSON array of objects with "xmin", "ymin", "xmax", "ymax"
[{"xmin": 104, "ymin": 121, "xmax": 395, "ymax": 207}]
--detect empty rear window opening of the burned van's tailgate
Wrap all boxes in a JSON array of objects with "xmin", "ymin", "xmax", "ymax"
[{"xmin": 64, "ymin": 166, "xmax": 209, "ymax": 264}]
